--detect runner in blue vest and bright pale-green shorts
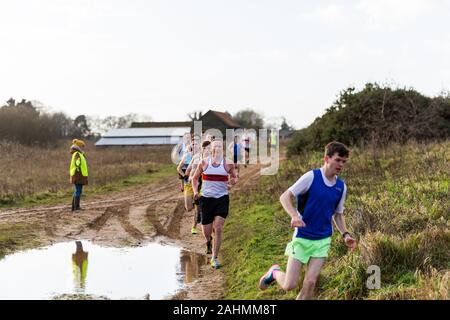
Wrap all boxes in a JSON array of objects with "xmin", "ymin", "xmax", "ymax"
[{"xmin": 259, "ymin": 141, "xmax": 357, "ymax": 300}]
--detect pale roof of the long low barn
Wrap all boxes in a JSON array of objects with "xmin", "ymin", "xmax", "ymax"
[{"xmin": 103, "ymin": 127, "xmax": 191, "ymax": 138}]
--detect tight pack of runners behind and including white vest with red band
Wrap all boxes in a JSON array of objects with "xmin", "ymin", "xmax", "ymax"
[{"xmin": 177, "ymin": 134, "xmax": 243, "ymax": 269}]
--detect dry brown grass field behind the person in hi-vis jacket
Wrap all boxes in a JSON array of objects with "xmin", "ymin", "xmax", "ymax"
[{"xmin": 0, "ymin": 141, "xmax": 176, "ymax": 207}]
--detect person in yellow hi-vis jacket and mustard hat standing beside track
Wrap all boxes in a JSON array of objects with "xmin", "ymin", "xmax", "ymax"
[{"xmin": 69, "ymin": 139, "xmax": 88, "ymax": 211}]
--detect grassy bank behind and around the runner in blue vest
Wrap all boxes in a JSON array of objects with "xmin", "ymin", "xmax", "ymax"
[{"xmin": 223, "ymin": 141, "xmax": 450, "ymax": 299}]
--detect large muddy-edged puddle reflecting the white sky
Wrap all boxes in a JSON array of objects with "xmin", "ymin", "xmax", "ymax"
[{"xmin": 0, "ymin": 241, "xmax": 207, "ymax": 300}]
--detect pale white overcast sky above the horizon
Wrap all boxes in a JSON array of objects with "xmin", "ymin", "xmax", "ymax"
[{"xmin": 0, "ymin": 0, "xmax": 450, "ymax": 128}]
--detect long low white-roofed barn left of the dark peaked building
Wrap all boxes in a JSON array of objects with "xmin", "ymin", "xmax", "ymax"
[{"xmin": 95, "ymin": 127, "xmax": 191, "ymax": 147}]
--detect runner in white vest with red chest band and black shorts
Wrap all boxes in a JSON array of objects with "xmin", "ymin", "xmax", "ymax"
[{"xmin": 192, "ymin": 140, "xmax": 238, "ymax": 269}]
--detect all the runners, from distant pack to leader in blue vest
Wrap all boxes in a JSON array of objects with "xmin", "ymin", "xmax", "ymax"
[{"xmin": 174, "ymin": 132, "xmax": 357, "ymax": 299}]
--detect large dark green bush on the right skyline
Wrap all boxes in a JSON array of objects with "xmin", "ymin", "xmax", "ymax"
[{"xmin": 288, "ymin": 83, "xmax": 450, "ymax": 155}]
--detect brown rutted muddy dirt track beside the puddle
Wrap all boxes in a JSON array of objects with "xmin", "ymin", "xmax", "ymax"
[{"xmin": 0, "ymin": 165, "xmax": 266, "ymax": 300}]
